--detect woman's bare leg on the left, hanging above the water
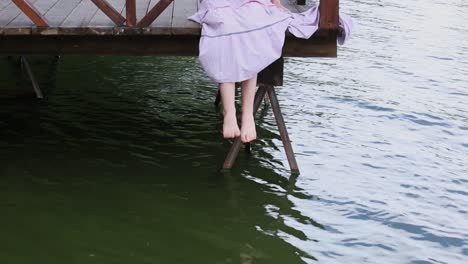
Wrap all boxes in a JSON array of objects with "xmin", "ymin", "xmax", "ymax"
[{"xmin": 219, "ymin": 83, "xmax": 240, "ymax": 138}]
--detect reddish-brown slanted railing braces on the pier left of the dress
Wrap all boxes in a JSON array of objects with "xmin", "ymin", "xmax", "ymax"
[{"xmin": 12, "ymin": 0, "xmax": 174, "ymax": 27}]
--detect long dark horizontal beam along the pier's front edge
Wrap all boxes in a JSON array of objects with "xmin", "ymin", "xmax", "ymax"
[{"xmin": 0, "ymin": 35, "xmax": 337, "ymax": 57}]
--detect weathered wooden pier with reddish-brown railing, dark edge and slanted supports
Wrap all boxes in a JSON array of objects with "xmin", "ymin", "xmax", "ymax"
[{"xmin": 0, "ymin": 0, "xmax": 339, "ymax": 172}]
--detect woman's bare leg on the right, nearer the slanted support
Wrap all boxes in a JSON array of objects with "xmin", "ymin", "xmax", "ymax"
[{"xmin": 240, "ymin": 75, "xmax": 257, "ymax": 143}]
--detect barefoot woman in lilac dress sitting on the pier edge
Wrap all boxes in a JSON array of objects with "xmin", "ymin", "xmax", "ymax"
[{"xmin": 189, "ymin": 0, "xmax": 351, "ymax": 143}]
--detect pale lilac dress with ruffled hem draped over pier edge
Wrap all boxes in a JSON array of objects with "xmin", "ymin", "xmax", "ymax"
[{"xmin": 189, "ymin": 0, "xmax": 352, "ymax": 83}]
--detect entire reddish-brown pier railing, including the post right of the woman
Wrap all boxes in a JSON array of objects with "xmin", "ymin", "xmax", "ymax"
[{"xmin": 12, "ymin": 0, "xmax": 339, "ymax": 30}]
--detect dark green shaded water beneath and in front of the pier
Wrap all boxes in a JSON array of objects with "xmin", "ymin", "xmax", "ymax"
[{"xmin": 0, "ymin": 57, "xmax": 315, "ymax": 263}]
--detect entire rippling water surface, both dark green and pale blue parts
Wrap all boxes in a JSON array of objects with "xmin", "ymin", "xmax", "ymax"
[{"xmin": 0, "ymin": 0, "xmax": 468, "ymax": 264}]
